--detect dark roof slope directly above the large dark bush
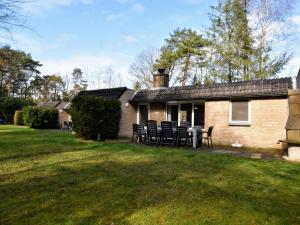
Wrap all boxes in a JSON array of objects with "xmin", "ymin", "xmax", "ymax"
[{"xmin": 79, "ymin": 87, "xmax": 128, "ymax": 100}]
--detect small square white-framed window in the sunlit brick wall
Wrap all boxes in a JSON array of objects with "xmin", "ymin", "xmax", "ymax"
[{"xmin": 229, "ymin": 101, "xmax": 251, "ymax": 125}]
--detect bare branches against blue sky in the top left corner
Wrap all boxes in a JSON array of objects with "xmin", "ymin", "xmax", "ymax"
[{"xmin": 0, "ymin": 0, "xmax": 26, "ymax": 32}]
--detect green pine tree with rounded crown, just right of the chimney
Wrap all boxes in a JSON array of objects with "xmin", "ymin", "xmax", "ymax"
[{"xmin": 155, "ymin": 28, "xmax": 208, "ymax": 86}]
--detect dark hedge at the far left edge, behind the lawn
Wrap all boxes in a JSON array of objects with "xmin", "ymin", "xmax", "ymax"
[{"xmin": 0, "ymin": 97, "xmax": 34, "ymax": 123}]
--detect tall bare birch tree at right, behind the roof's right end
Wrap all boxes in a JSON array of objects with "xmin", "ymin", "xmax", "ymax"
[{"xmin": 247, "ymin": 0, "xmax": 293, "ymax": 79}]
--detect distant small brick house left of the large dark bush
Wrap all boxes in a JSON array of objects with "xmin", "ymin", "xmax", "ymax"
[{"xmin": 38, "ymin": 101, "xmax": 72, "ymax": 128}]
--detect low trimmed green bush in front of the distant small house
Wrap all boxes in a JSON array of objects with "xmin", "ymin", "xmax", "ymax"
[{"xmin": 23, "ymin": 106, "xmax": 58, "ymax": 129}]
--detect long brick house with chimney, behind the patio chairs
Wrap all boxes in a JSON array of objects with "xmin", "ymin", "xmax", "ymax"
[{"xmin": 130, "ymin": 71, "xmax": 293, "ymax": 149}]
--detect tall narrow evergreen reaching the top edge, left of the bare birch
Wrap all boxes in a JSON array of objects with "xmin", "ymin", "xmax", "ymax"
[{"xmin": 208, "ymin": 0, "xmax": 253, "ymax": 83}]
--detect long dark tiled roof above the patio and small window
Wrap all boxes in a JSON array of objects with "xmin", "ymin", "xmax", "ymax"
[{"xmin": 131, "ymin": 78, "xmax": 293, "ymax": 102}]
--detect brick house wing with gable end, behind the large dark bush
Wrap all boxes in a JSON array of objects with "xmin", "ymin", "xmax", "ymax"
[{"xmin": 80, "ymin": 87, "xmax": 136, "ymax": 137}]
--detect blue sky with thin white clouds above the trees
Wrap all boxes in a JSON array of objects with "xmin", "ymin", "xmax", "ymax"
[{"xmin": 1, "ymin": 0, "xmax": 300, "ymax": 89}]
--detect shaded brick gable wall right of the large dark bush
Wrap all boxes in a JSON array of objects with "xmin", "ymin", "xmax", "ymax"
[{"xmin": 119, "ymin": 90, "xmax": 137, "ymax": 137}]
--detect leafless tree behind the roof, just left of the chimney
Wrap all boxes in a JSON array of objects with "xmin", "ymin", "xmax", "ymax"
[{"xmin": 129, "ymin": 48, "xmax": 159, "ymax": 88}]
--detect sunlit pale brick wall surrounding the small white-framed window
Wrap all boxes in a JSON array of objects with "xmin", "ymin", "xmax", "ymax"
[{"xmin": 205, "ymin": 99, "xmax": 288, "ymax": 149}]
